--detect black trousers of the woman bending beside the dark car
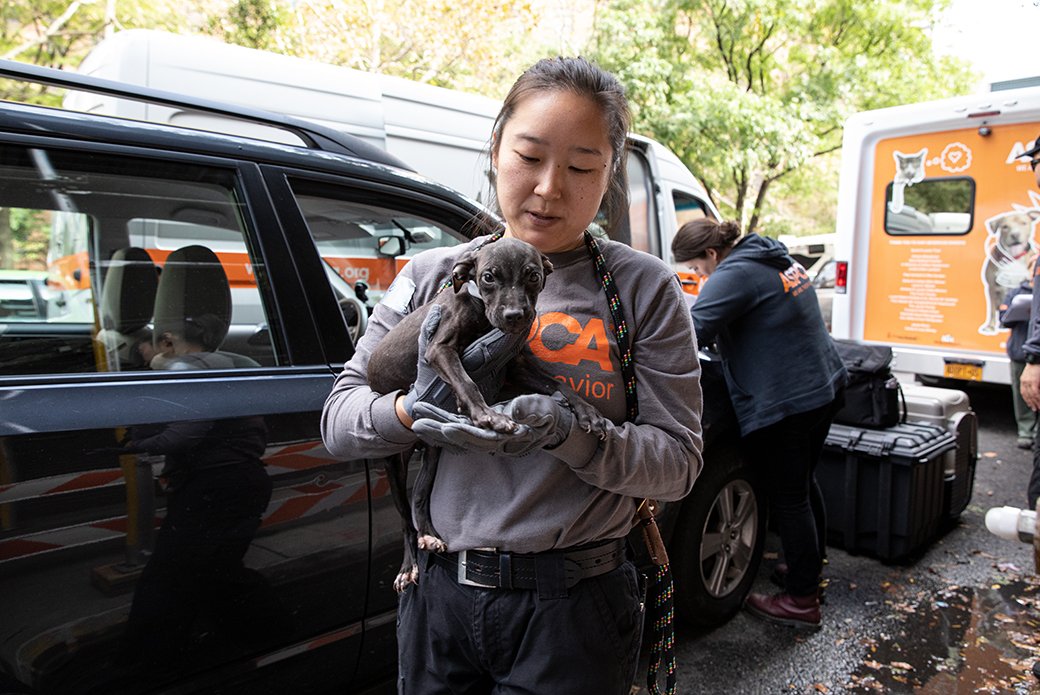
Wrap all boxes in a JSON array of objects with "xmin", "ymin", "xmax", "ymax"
[{"xmin": 744, "ymin": 393, "xmax": 844, "ymax": 596}]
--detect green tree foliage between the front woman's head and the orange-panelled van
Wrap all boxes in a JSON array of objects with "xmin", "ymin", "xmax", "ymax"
[{"xmin": 593, "ymin": 0, "xmax": 974, "ymax": 231}]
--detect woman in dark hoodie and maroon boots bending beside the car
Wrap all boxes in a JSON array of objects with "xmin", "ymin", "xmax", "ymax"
[{"xmin": 672, "ymin": 218, "xmax": 848, "ymax": 626}]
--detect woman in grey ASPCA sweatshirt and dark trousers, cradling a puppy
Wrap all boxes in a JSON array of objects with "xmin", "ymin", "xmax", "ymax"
[{"xmin": 322, "ymin": 58, "xmax": 702, "ymax": 694}]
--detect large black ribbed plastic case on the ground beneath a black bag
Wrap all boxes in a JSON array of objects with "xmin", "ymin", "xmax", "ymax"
[{"xmin": 816, "ymin": 423, "xmax": 957, "ymax": 561}]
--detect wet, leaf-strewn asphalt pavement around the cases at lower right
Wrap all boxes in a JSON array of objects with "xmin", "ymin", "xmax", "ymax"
[{"xmin": 632, "ymin": 384, "xmax": 1040, "ymax": 695}]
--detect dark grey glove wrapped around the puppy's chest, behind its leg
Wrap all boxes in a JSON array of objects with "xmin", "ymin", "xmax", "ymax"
[{"xmin": 402, "ymin": 304, "xmax": 527, "ymax": 419}]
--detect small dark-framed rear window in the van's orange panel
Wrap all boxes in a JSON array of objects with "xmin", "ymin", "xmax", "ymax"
[{"xmin": 885, "ymin": 177, "xmax": 974, "ymax": 236}]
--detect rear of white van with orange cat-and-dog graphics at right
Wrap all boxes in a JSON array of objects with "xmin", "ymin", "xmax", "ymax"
[{"xmin": 831, "ymin": 87, "xmax": 1040, "ymax": 384}]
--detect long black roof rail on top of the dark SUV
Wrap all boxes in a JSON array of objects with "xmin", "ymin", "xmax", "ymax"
[{"xmin": 0, "ymin": 59, "xmax": 415, "ymax": 172}]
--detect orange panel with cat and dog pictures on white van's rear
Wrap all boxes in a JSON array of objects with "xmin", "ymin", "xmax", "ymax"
[{"xmin": 863, "ymin": 124, "xmax": 1040, "ymax": 355}]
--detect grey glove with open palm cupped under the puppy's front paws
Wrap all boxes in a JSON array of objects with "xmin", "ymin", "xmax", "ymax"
[{"xmin": 412, "ymin": 391, "xmax": 574, "ymax": 457}]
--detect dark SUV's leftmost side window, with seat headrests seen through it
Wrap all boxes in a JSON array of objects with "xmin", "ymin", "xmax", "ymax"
[{"xmin": 0, "ymin": 146, "xmax": 284, "ymax": 376}]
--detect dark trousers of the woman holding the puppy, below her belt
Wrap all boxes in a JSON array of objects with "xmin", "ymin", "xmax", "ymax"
[{"xmin": 397, "ymin": 552, "xmax": 643, "ymax": 695}]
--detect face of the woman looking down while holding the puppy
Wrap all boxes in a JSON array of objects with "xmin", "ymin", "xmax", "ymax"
[{"xmin": 492, "ymin": 92, "xmax": 613, "ymax": 254}]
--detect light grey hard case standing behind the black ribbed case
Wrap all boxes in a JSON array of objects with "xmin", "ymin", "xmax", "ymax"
[{"xmin": 902, "ymin": 384, "xmax": 979, "ymax": 518}]
